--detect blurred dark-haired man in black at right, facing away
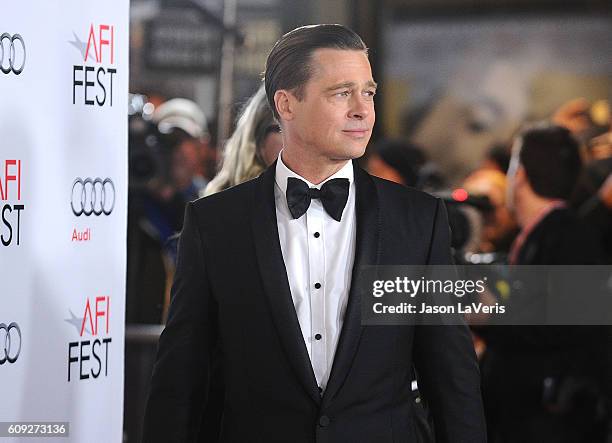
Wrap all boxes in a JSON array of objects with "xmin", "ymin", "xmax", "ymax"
[{"xmin": 478, "ymin": 124, "xmax": 608, "ymax": 443}]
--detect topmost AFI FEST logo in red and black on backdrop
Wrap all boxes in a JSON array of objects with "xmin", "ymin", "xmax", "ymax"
[{"xmin": 70, "ymin": 23, "xmax": 117, "ymax": 106}]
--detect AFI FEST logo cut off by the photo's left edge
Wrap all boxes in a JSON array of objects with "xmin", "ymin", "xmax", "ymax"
[{"xmin": 0, "ymin": 159, "xmax": 25, "ymax": 246}]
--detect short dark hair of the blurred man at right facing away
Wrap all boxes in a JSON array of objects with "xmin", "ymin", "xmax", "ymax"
[{"xmin": 519, "ymin": 124, "xmax": 582, "ymax": 199}]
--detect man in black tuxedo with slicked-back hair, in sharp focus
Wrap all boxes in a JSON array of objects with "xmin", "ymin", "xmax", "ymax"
[{"xmin": 144, "ymin": 25, "xmax": 486, "ymax": 443}]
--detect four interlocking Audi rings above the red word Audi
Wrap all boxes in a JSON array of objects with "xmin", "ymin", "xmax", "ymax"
[{"xmin": 70, "ymin": 177, "xmax": 115, "ymax": 217}]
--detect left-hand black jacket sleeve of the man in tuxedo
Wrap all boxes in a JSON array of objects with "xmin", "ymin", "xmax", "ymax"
[{"xmin": 143, "ymin": 203, "xmax": 217, "ymax": 443}]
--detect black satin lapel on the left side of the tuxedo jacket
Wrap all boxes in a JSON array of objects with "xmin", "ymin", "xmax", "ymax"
[{"xmin": 251, "ymin": 162, "xmax": 321, "ymax": 404}]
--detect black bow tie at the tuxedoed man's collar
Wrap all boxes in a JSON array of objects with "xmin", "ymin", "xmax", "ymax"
[{"xmin": 286, "ymin": 177, "xmax": 349, "ymax": 221}]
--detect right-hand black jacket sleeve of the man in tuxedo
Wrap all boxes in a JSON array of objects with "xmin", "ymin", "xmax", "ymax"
[{"xmin": 414, "ymin": 200, "xmax": 486, "ymax": 443}]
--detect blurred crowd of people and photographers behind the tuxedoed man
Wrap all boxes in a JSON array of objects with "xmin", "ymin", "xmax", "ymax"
[{"xmin": 127, "ymin": 88, "xmax": 612, "ymax": 443}]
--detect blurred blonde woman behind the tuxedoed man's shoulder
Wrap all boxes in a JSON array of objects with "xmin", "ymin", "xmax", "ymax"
[{"xmin": 204, "ymin": 85, "xmax": 282, "ymax": 195}]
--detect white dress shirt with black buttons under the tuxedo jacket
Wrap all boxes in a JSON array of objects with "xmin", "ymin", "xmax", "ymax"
[{"xmin": 274, "ymin": 151, "xmax": 355, "ymax": 390}]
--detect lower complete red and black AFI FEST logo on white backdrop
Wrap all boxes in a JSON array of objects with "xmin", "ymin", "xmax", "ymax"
[{"xmin": 65, "ymin": 296, "xmax": 112, "ymax": 382}]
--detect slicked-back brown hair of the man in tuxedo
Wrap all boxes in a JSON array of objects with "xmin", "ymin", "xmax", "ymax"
[{"xmin": 264, "ymin": 25, "xmax": 368, "ymax": 122}]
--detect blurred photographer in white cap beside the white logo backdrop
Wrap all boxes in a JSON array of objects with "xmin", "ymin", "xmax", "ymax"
[{"xmin": 126, "ymin": 95, "xmax": 214, "ymax": 324}]
